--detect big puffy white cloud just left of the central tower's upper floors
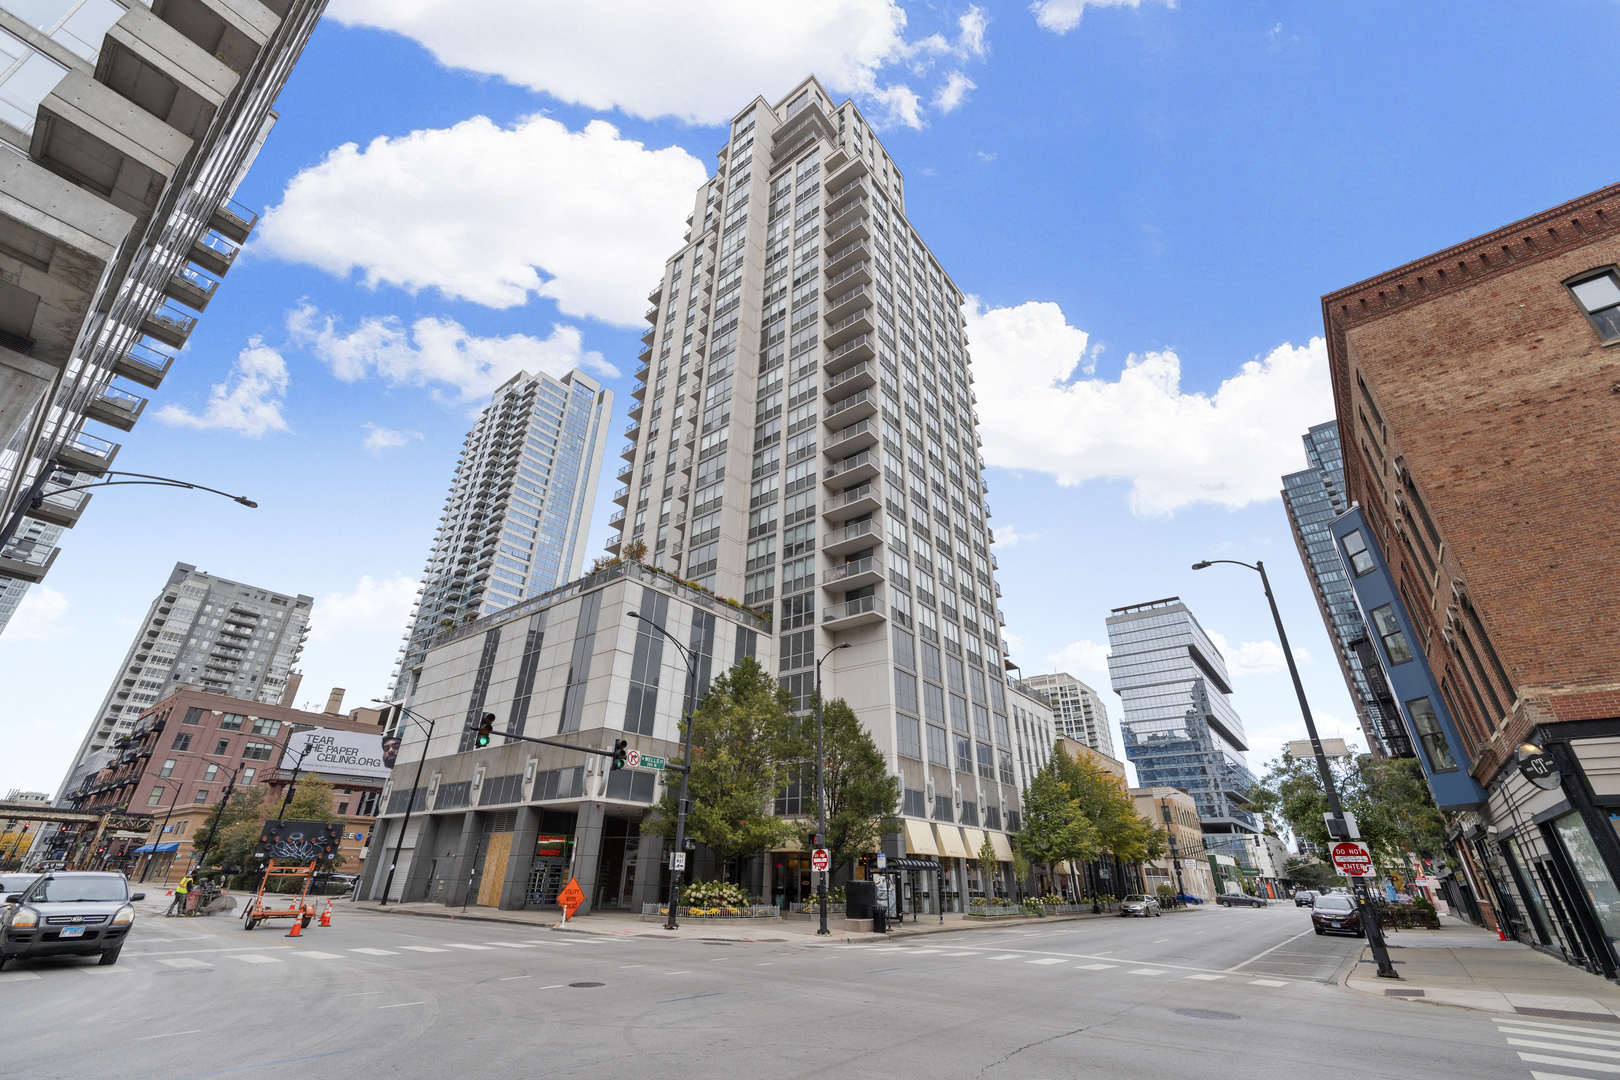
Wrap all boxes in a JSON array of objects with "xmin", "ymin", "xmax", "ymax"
[{"xmin": 258, "ymin": 115, "xmax": 708, "ymax": 325}]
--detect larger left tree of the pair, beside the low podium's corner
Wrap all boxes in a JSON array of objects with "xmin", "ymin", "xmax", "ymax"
[{"xmin": 642, "ymin": 656, "xmax": 799, "ymax": 873}]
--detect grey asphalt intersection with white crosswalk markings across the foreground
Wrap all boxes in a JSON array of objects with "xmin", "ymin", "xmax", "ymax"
[{"xmin": 0, "ymin": 905, "xmax": 1600, "ymax": 1080}]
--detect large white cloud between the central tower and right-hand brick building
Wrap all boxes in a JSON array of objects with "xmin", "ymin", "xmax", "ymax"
[{"xmin": 967, "ymin": 300, "xmax": 1333, "ymax": 515}]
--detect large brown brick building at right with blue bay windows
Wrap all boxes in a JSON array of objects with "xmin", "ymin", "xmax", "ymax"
[{"xmin": 1322, "ymin": 186, "xmax": 1620, "ymax": 978}]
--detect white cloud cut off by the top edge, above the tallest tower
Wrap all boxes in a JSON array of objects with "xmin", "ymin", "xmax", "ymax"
[{"xmin": 329, "ymin": 0, "xmax": 988, "ymax": 125}]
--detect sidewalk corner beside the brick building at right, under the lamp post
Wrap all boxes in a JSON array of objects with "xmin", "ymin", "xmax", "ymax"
[{"xmin": 1345, "ymin": 916, "xmax": 1620, "ymax": 1023}]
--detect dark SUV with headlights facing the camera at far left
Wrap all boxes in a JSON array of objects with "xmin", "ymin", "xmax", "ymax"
[{"xmin": 0, "ymin": 871, "xmax": 146, "ymax": 968}]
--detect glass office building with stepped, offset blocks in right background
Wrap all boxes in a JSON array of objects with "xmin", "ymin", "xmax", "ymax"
[{"xmin": 1108, "ymin": 596, "xmax": 1260, "ymax": 834}]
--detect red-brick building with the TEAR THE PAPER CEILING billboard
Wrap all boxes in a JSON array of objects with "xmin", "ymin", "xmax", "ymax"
[{"xmin": 62, "ymin": 690, "xmax": 389, "ymax": 881}]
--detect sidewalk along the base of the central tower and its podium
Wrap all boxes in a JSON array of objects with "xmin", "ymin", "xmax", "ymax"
[{"xmin": 334, "ymin": 900, "xmax": 1159, "ymax": 942}]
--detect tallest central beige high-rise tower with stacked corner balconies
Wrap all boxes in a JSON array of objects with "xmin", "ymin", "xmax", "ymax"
[{"xmin": 609, "ymin": 78, "xmax": 1019, "ymax": 840}]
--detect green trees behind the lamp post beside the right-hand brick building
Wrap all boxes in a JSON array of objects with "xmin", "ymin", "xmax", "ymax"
[{"xmin": 1251, "ymin": 746, "xmax": 1445, "ymax": 870}]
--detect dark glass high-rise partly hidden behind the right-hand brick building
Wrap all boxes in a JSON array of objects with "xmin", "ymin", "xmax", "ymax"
[{"xmin": 1283, "ymin": 421, "xmax": 1413, "ymax": 758}]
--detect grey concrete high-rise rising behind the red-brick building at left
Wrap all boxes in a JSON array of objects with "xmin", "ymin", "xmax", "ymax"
[{"xmin": 57, "ymin": 562, "xmax": 314, "ymax": 798}]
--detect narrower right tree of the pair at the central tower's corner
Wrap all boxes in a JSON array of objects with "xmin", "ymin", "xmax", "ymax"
[{"xmin": 797, "ymin": 698, "xmax": 901, "ymax": 866}]
